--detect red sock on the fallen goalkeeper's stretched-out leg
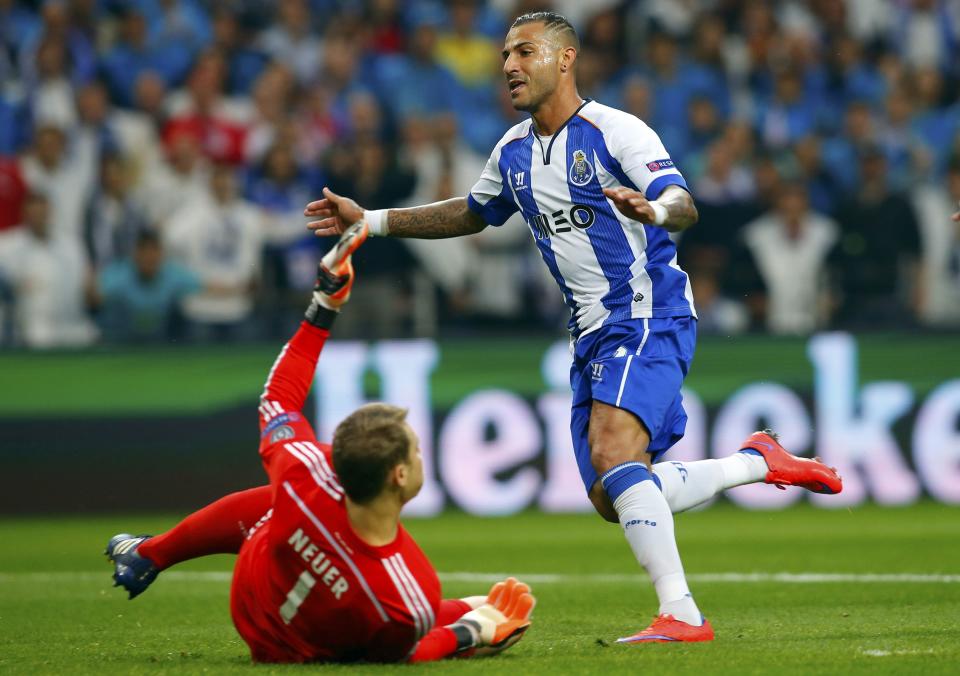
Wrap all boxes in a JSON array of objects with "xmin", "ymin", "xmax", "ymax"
[{"xmin": 137, "ymin": 486, "xmax": 273, "ymax": 570}]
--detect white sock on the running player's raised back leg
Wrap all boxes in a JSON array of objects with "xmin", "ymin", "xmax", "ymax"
[{"xmin": 653, "ymin": 453, "xmax": 767, "ymax": 513}]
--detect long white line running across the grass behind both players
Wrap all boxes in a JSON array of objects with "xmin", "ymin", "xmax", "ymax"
[{"xmin": 0, "ymin": 569, "xmax": 960, "ymax": 584}]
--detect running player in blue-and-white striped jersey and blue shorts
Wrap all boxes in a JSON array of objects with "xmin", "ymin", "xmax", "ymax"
[{"xmin": 304, "ymin": 12, "xmax": 841, "ymax": 643}]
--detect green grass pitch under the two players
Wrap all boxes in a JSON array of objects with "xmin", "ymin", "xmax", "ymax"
[{"xmin": 0, "ymin": 503, "xmax": 960, "ymax": 676}]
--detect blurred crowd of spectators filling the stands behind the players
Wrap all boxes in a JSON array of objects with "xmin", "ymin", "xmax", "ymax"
[{"xmin": 0, "ymin": 0, "xmax": 960, "ymax": 347}]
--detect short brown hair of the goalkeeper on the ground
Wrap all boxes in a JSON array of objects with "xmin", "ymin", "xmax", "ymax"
[{"xmin": 333, "ymin": 404, "xmax": 411, "ymax": 505}]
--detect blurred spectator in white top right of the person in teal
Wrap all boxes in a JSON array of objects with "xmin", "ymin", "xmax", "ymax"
[{"xmin": 163, "ymin": 164, "xmax": 263, "ymax": 340}]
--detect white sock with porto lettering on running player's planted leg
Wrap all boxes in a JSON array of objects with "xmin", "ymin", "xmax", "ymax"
[{"xmin": 613, "ymin": 481, "xmax": 703, "ymax": 626}]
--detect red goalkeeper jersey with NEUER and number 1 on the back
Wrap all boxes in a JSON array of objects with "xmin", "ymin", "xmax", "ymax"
[{"xmin": 230, "ymin": 324, "xmax": 444, "ymax": 662}]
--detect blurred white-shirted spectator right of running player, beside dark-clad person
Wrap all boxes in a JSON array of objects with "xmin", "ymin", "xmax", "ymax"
[{"xmin": 743, "ymin": 183, "xmax": 839, "ymax": 334}]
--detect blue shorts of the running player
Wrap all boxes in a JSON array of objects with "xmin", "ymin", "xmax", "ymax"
[{"xmin": 570, "ymin": 317, "xmax": 697, "ymax": 493}]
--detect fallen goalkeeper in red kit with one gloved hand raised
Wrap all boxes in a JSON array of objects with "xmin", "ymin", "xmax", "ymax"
[{"xmin": 107, "ymin": 221, "xmax": 534, "ymax": 662}]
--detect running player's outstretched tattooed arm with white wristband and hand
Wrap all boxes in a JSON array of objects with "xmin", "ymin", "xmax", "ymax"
[{"xmin": 303, "ymin": 188, "xmax": 487, "ymax": 239}]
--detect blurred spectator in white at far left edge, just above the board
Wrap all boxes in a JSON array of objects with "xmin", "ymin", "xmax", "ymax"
[{"xmin": 0, "ymin": 192, "xmax": 97, "ymax": 348}]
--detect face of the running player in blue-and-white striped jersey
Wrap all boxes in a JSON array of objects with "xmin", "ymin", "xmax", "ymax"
[{"xmin": 502, "ymin": 23, "xmax": 563, "ymax": 113}]
